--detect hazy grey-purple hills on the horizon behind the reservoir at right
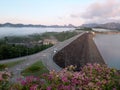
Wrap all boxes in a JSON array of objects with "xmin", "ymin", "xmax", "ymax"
[{"xmin": 81, "ymin": 22, "xmax": 120, "ymax": 30}]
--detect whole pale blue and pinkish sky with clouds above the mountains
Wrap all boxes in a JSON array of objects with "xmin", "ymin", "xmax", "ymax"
[{"xmin": 0, "ymin": 0, "xmax": 120, "ymax": 26}]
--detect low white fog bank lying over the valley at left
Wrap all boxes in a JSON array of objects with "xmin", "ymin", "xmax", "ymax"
[{"xmin": 0, "ymin": 27, "xmax": 74, "ymax": 38}]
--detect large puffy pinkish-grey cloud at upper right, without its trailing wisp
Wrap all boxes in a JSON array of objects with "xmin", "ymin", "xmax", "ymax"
[{"xmin": 82, "ymin": 0, "xmax": 120, "ymax": 19}]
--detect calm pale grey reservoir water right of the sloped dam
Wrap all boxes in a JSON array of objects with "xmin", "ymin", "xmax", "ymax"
[{"xmin": 94, "ymin": 34, "xmax": 120, "ymax": 70}]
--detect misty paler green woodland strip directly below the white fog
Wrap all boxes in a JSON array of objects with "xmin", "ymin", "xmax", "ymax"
[{"xmin": 0, "ymin": 31, "xmax": 77, "ymax": 43}]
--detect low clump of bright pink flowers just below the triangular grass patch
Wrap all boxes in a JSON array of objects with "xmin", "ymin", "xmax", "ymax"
[{"xmin": 11, "ymin": 76, "xmax": 44, "ymax": 90}]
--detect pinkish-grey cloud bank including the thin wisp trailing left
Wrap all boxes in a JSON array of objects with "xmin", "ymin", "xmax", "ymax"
[{"xmin": 70, "ymin": 0, "xmax": 120, "ymax": 23}]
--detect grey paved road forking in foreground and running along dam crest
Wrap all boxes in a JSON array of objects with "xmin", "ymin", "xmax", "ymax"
[{"xmin": 0, "ymin": 33, "xmax": 84, "ymax": 82}]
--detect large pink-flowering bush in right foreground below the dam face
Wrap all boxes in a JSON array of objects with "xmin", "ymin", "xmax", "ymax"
[{"xmin": 45, "ymin": 64, "xmax": 120, "ymax": 90}]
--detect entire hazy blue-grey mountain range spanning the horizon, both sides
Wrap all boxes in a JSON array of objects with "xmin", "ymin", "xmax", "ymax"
[{"xmin": 0, "ymin": 22, "xmax": 120, "ymax": 30}]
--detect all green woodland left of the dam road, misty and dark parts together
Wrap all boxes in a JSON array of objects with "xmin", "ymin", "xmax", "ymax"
[{"xmin": 0, "ymin": 31, "xmax": 77, "ymax": 60}]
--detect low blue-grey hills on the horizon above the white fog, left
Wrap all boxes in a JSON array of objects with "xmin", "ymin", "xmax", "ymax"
[{"xmin": 0, "ymin": 23, "xmax": 75, "ymax": 28}]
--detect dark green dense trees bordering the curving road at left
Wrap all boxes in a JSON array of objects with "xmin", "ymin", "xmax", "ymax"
[{"xmin": 0, "ymin": 44, "xmax": 52, "ymax": 59}]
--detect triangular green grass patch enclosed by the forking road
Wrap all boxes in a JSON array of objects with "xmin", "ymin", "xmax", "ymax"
[{"xmin": 21, "ymin": 61, "xmax": 49, "ymax": 76}]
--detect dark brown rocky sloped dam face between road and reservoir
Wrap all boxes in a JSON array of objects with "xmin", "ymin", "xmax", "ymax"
[{"xmin": 53, "ymin": 33, "xmax": 105, "ymax": 69}]
